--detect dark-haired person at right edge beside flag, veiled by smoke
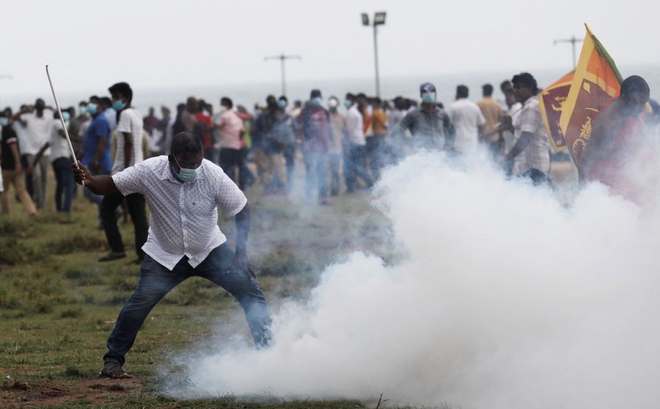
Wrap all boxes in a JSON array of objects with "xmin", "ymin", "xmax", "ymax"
[{"xmin": 578, "ymin": 75, "xmax": 657, "ymax": 203}]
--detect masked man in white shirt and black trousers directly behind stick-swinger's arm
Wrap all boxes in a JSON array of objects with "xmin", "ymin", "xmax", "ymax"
[{"xmin": 99, "ymin": 82, "xmax": 149, "ymax": 263}]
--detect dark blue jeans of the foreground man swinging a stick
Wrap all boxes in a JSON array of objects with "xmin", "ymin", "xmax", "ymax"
[{"xmin": 103, "ymin": 243, "xmax": 271, "ymax": 365}]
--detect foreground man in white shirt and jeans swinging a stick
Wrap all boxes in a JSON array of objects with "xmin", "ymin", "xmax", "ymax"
[{"xmin": 74, "ymin": 132, "xmax": 271, "ymax": 378}]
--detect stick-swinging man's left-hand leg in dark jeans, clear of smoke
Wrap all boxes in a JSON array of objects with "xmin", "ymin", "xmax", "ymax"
[{"xmin": 103, "ymin": 256, "xmax": 189, "ymax": 365}]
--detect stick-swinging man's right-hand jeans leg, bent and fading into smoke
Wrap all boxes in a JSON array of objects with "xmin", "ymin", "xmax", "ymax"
[{"xmin": 195, "ymin": 243, "xmax": 272, "ymax": 349}]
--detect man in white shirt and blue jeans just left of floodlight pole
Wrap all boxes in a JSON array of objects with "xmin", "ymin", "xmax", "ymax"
[{"xmin": 344, "ymin": 93, "xmax": 373, "ymax": 193}]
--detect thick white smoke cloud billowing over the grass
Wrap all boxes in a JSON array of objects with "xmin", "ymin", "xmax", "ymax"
[{"xmin": 170, "ymin": 153, "xmax": 660, "ymax": 409}]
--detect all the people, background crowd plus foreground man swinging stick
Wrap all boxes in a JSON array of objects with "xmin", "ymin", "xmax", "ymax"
[{"xmin": 0, "ymin": 73, "xmax": 658, "ymax": 378}]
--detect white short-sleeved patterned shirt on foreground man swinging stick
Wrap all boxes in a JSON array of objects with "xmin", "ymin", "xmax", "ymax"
[{"xmin": 112, "ymin": 155, "xmax": 247, "ymax": 270}]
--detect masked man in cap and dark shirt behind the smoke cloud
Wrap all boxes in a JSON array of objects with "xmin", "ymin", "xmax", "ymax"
[{"xmin": 392, "ymin": 82, "xmax": 455, "ymax": 150}]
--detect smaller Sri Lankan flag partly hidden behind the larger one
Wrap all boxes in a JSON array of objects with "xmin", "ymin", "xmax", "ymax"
[{"xmin": 539, "ymin": 70, "xmax": 575, "ymax": 152}]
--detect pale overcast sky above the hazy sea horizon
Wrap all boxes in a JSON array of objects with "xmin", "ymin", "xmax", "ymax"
[{"xmin": 0, "ymin": 0, "xmax": 660, "ymax": 100}]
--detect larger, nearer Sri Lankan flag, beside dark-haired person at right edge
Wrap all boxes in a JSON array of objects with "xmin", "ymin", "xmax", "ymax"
[{"xmin": 559, "ymin": 24, "xmax": 623, "ymax": 164}]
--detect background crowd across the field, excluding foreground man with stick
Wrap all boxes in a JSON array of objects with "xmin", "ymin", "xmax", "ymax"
[{"xmin": 0, "ymin": 73, "xmax": 657, "ymax": 249}]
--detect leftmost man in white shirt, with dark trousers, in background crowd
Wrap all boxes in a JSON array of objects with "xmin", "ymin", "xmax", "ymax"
[{"xmin": 15, "ymin": 98, "xmax": 53, "ymax": 210}]
